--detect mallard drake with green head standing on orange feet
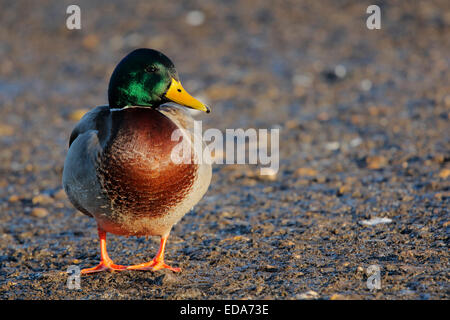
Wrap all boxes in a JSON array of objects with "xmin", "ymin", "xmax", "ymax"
[{"xmin": 63, "ymin": 49, "xmax": 211, "ymax": 274}]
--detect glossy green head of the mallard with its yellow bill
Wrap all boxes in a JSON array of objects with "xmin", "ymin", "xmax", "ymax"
[{"xmin": 108, "ymin": 49, "xmax": 210, "ymax": 112}]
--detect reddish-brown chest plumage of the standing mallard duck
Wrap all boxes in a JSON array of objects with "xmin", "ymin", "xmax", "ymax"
[{"xmin": 97, "ymin": 108, "xmax": 198, "ymax": 218}]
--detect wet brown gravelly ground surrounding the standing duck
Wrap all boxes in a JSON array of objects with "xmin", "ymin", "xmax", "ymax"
[{"xmin": 0, "ymin": 0, "xmax": 450, "ymax": 299}]
